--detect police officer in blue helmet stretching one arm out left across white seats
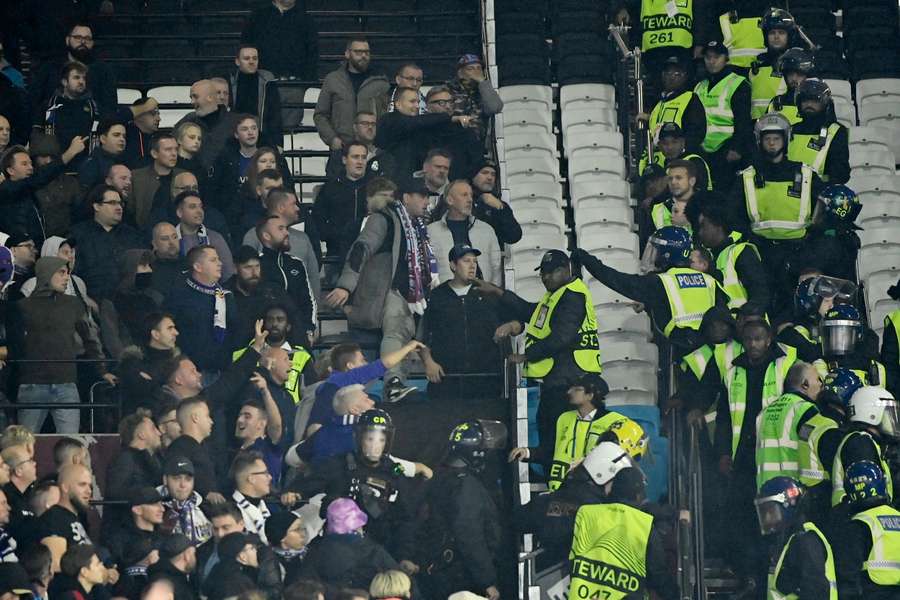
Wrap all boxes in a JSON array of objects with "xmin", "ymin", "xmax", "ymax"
[{"xmin": 572, "ymin": 226, "xmax": 728, "ymax": 354}]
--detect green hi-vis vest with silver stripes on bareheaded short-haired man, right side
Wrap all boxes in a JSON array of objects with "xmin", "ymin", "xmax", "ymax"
[{"xmin": 756, "ymin": 392, "xmax": 815, "ymax": 489}]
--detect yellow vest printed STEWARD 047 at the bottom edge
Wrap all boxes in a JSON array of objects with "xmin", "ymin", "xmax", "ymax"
[{"xmin": 569, "ymin": 503, "xmax": 653, "ymax": 600}]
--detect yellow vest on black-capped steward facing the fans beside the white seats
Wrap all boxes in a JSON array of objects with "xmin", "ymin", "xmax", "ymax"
[{"xmin": 525, "ymin": 279, "xmax": 602, "ymax": 378}]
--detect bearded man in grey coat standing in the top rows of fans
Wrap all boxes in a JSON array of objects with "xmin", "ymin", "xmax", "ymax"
[{"xmin": 313, "ymin": 38, "xmax": 391, "ymax": 150}]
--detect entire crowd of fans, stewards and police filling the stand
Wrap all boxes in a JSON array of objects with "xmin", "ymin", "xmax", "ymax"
[{"xmin": 0, "ymin": 0, "xmax": 900, "ymax": 600}]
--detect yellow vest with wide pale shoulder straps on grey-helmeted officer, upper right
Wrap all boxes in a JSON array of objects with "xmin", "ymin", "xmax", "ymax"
[{"xmin": 741, "ymin": 165, "xmax": 813, "ymax": 240}]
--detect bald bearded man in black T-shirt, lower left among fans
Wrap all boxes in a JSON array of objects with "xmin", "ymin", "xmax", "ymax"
[{"xmin": 36, "ymin": 463, "xmax": 93, "ymax": 564}]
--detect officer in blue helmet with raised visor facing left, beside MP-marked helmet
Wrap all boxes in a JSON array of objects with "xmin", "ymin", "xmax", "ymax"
[{"xmin": 756, "ymin": 476, "xmax": 838, "ymax": 600}]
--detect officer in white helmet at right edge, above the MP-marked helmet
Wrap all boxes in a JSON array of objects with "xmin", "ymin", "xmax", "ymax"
[{"xmin": 819, "ymin": 386, "xmax": 900, "ymax": 509}]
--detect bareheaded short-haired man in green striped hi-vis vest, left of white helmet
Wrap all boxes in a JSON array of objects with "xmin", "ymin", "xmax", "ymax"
[{"xmin": 756, "ymin": 361, "xmax": 822, "ymax": 488}]
